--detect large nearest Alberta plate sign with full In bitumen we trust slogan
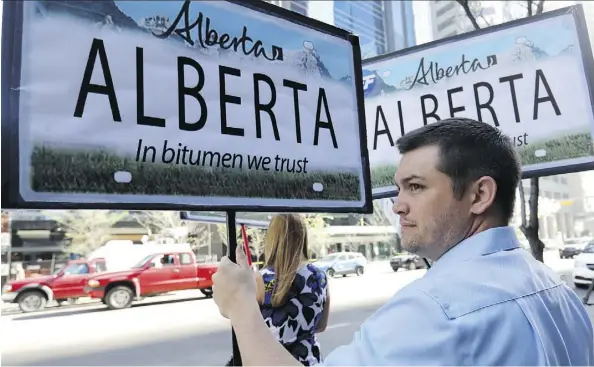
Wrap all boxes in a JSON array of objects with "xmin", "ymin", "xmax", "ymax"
[{"xmin": 2, "ymin": 0, "xmax": 370, "ymax": 211}]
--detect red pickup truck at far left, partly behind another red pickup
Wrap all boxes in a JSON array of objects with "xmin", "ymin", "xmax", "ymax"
[{"xmin": 2, "ymin": 258, "xmax": 107, "ymax": 312}]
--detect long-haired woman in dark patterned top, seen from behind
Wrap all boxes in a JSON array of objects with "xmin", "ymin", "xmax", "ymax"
[{"xmin": 227, "ymin": 214, "xmax": 330, "ymax": 366}]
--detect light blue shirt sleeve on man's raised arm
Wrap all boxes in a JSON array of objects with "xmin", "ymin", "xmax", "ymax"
[{"xmin": 323, "ymin": 288, "xmax": 463, "ymax": 366}]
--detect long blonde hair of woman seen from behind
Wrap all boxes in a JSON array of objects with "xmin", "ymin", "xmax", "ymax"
[{"xmin": 264, "ymin": 214, "xmax": 308, "ymax": 307}]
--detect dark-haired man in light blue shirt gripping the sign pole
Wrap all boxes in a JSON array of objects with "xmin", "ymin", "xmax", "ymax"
[{"xmin": 213, "ymin": 118, "xmax": 594, "ymax": 366}]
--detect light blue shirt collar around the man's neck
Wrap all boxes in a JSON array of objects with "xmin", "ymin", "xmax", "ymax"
[{"xmin": 432, "ymin": 226, "xmax": 520, "ymax": 268}]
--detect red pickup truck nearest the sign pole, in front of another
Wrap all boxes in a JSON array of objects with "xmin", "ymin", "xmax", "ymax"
[{"xmin": 85, "ymin": 250, "xmax": 218, "ymax": 310}]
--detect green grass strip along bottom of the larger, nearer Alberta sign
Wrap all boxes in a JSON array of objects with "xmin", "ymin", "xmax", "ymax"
[{"xmin": 31, "ymin": 146, "xmax": 361, "ymax": 201}]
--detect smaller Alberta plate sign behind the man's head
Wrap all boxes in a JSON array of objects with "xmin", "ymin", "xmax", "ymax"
[{"xmin": 363, "ymin": 7, "xmax": 594, "ymax": 197}]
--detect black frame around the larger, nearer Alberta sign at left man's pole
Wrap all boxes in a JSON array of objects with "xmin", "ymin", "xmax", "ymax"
[{"xmin": 1, "ymin": 0, "xmax": 373, "ymax": 213}]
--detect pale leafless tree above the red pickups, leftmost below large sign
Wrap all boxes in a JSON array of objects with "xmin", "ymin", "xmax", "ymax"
[{"xmin": 43, "ymin": 210, "xmax": 128, "ymax": 255}]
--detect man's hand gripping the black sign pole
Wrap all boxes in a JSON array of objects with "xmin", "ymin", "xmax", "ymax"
[{"xmin": 212, "ymin": 246, "xmax": 256, "ymax": 318}]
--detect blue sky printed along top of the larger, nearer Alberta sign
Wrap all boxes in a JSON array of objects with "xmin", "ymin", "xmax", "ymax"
[{"xmin": 116, "ymin": 1, "xmax": 352, "ymax": 78}]
